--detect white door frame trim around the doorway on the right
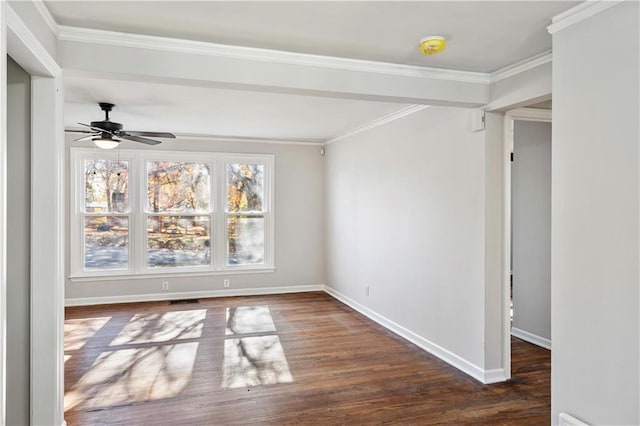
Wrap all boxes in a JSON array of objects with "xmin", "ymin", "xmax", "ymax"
[{"xmin": 502, "ymin": 108, "xmax": 552, "ymax": 379}]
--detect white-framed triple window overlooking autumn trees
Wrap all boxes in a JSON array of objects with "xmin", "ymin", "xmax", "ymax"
[{"xmin": 71, "ymin": 148, "xmax": 273, "ymax": 278}]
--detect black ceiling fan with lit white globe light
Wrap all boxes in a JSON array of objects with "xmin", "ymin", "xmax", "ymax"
[{"xmin": 66, "ymin": 102, "xmax": 176, "ymax": 149}]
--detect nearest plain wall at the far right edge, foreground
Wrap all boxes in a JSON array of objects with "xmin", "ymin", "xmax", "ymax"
[{"xmin": 551, "ymin": 1, "xmax": 640, "ymax": 425}]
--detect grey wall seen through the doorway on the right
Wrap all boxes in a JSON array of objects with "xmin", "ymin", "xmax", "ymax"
[{"xmin": 511, "ymin": 120, "xmax": 551, "ymax": 345}]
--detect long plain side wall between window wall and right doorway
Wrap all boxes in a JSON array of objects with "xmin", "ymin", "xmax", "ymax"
[{"xmin": 326, "ymin": 107, "xmax": 502, "ymax": 377}]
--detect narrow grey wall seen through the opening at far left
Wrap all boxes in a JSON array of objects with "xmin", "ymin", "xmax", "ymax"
[{"xmin": 6, "ymin": 57, "xmax": 31, "ymax": 425}]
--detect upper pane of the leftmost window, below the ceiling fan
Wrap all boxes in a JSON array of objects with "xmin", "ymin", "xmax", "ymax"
[{"xmin": 84, "ymin": 159, "xmax": 129, "ymax": 213}]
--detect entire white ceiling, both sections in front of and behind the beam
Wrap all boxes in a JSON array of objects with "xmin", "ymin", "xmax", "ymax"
[{"xmin": 45, "ymin": 0, "xmax": 579, "ymax": 140}]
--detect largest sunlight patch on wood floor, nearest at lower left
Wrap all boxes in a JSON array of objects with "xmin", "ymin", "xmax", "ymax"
[{"xmin": 64, "ymin": 342, "xmax": 198, "ymax": 411}]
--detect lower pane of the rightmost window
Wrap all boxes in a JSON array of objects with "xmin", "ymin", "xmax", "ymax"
[{"xmin": 227, "ymin": 216, "xmax": 264, "ymax": 265}]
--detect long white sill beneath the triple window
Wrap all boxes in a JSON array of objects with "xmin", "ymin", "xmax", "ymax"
[{"xmin": 68, "ymin": 266, "xmax": 276, "ymax": 283}]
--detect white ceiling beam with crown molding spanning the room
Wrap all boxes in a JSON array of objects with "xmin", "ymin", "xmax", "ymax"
[{"xmin": 58, "ymin": 27, "xmax": 489, "ymax": 107}]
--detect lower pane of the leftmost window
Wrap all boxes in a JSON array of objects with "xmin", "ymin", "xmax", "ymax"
[{"xmin": 84, "ymin": 216, "xmax": 129, "ymax": 270}]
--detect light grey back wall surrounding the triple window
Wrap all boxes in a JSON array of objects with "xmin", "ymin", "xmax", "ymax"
[{"xmin": 66, "ymin": 139, "xmax": 324, "ymax": 304}]
